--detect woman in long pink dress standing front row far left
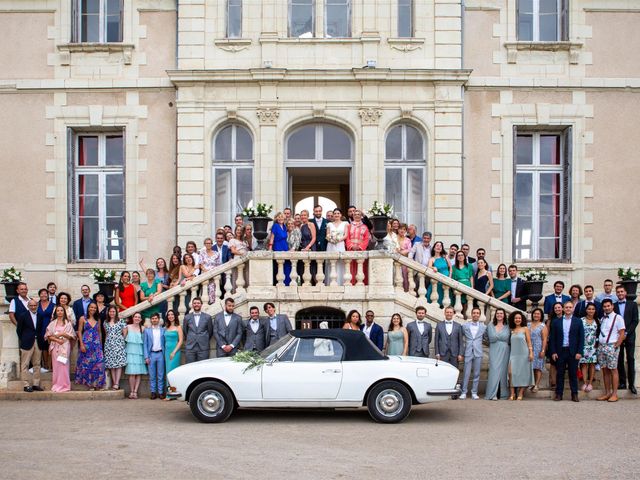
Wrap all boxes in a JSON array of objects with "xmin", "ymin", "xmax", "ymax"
[{"xmin": 45, "ymin": 305, "xmax": 76, "ymax": 392}]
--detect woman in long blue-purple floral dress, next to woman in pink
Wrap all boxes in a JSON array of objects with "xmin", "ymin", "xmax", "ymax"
[{"xmin": 75, "ymin": 302, "xmax": 105, "ymax": 390}]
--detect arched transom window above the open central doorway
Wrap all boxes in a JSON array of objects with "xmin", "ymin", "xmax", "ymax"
[{"xmin": 287, "ymin": 123, "xmax": 352, "ymax": 165}]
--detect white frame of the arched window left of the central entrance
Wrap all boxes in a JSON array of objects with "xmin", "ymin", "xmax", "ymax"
[{"xmin": 211, "ymin": 122, "xmax": 255, "ymax": 226}]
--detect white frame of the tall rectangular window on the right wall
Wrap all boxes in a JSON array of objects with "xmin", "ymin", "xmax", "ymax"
[{"xmin": 512, "ymin": 127, "xmax": 572, "ymax": 263}]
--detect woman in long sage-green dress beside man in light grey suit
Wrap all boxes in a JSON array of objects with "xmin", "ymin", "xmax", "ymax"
[{"xmin": 485, "ymin": 308, "xmax": 511, "ymax": 400}]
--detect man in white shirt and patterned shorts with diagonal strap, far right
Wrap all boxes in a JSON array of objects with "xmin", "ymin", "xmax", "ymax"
[{"xmin": 598, "ymin": 298, "xmax": 625, "ymax": 402}]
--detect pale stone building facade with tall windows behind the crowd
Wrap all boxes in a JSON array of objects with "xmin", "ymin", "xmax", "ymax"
[{"xmin": 0, "ymin": 0, "xmax": 640, "ymax": 292}]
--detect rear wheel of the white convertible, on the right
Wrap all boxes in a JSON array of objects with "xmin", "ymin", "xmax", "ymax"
[{"xmin": 367, "ymin": 380, "xmax": 411, "ymax": 423}]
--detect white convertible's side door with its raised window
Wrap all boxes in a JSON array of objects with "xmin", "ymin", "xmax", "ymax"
[{"xmin": 262, "ymin": 338, "xmax": 344, "ymax": 401}]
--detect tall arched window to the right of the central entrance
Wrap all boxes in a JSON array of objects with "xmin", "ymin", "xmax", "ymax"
[{"xmin": 384, "ymin": 124, "xmax": 427, "ymax": 231}]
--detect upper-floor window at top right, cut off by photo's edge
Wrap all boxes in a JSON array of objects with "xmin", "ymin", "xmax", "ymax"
[{"xmin": 518, "ymin": 0, "xmax": 569, "ymax": 42}]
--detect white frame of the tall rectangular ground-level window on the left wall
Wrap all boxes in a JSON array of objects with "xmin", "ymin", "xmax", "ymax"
[{"xmin": 68, "ymin": 127, "xmax": 127, "ymax": 263}]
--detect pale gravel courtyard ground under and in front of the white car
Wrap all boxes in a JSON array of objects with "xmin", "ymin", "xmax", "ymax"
[{"xmin": 0, "ymin": 400, "xmax": 640, "ymax": 480}]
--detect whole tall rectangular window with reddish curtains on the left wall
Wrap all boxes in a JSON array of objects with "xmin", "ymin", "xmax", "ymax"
[{"xmin": 69, "ymin": 132, "xmax": 125, "ymax": 261}]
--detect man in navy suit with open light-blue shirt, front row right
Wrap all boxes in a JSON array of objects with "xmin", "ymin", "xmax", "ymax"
[{"xmin": 549, "ymin": 300, "xmax": 584, "ymax": 402}]
